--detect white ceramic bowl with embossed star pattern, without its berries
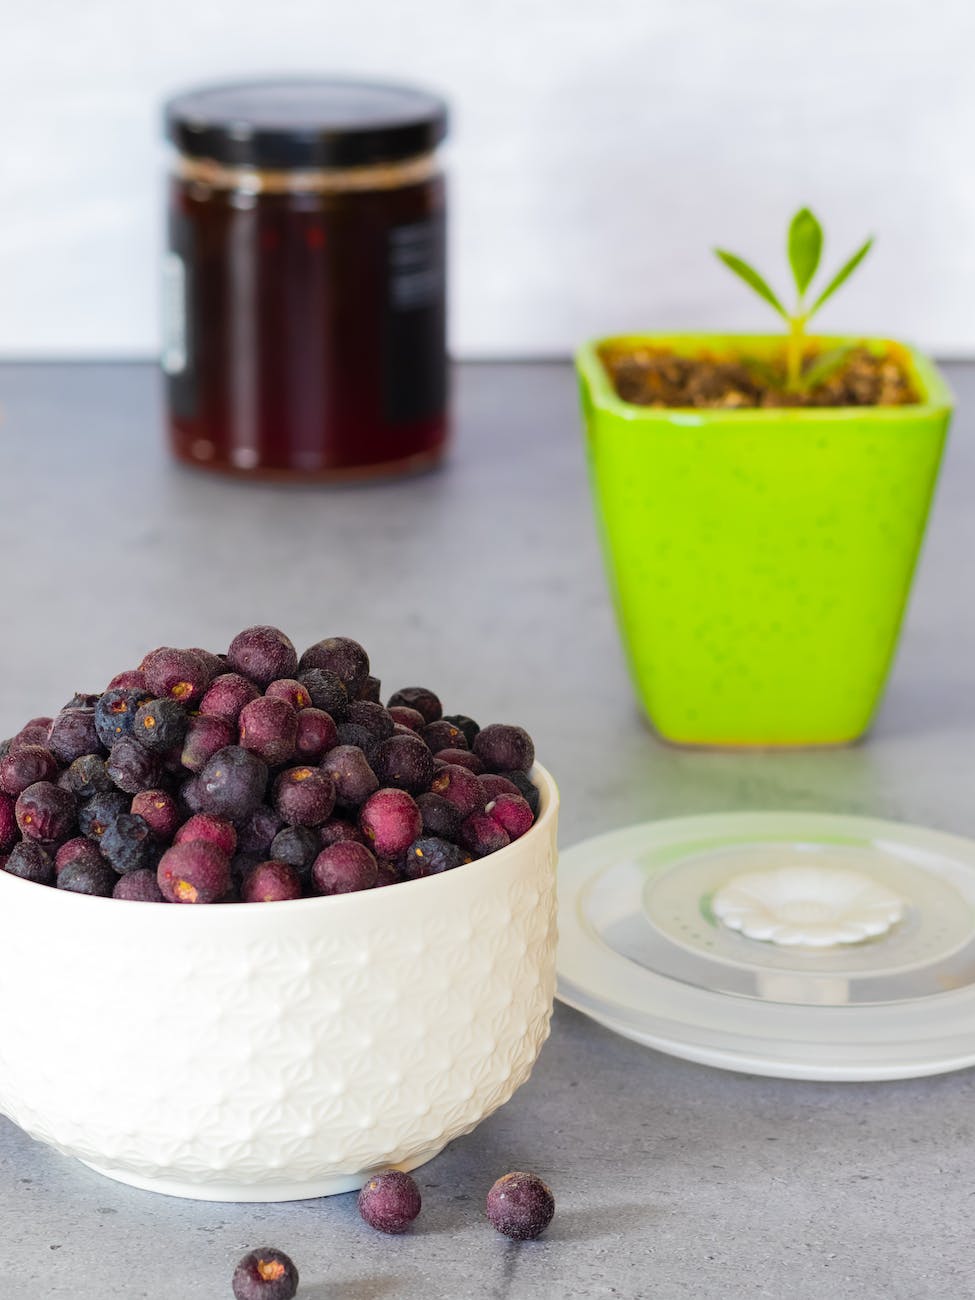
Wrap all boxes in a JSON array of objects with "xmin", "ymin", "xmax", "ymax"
[{"xmin": 0, "ymin": 766, "xmax": 558, "ymax": 1201}]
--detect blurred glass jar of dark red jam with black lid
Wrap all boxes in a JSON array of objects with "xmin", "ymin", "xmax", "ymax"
[{"xmin": 163, "ymin": 81, "xmax": 447, "ymax": 478}]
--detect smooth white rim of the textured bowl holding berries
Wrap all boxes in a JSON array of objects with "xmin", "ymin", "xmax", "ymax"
[{"xmin": 0, "ymin": 763, "xmax": 559, "ymax": 924}]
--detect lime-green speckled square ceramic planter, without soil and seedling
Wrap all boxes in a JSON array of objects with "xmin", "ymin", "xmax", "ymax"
[{"xmin": 577, "ymin": 335, "xmax": 952, "ymax": 745}]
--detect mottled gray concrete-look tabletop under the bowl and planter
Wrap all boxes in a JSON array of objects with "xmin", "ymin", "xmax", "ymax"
[{"xmin": 0, "ymin": 365, "xmax": 975, "ymax": 1300}]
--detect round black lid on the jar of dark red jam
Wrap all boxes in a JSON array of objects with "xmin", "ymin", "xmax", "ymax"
[{"xmin": 165, "ymin": 77, "xmax": 447, "ymax": 169}]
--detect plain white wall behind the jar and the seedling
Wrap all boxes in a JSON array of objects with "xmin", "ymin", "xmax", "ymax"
[{"xmin": 0, "ymin": 0, "xmax": 975, "ymax": 356}]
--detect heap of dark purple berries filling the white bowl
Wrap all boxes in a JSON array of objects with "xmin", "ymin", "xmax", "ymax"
[{"xmin": 0, "ymin": 627, "xmax": 538, "ymax": 904}]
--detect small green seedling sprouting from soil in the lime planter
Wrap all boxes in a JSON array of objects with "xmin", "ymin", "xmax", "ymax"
[{"xmin": 715, "ymin": 208, "xmax": 874, "ymax": 393}]
